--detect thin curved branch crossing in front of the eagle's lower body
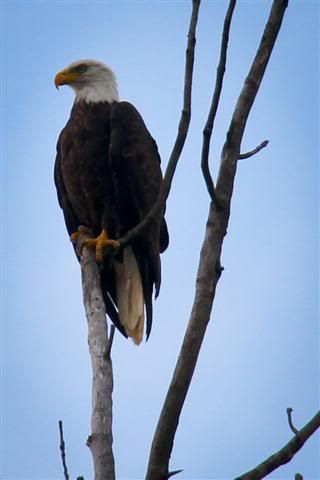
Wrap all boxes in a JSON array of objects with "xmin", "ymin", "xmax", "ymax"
[{"xmin": 118, "ymin": 0, "xmax": 200, "ymax": 248}]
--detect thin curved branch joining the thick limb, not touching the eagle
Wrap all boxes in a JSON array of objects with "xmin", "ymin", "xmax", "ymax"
[{"xmin": 201, "ymin": 0, "xmax": 236, "ymax": 205}]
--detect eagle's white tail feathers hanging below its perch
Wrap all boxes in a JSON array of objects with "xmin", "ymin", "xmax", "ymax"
[{"xmin": 115, "ymin": 247, "xmax": 144, "ymax": 345}]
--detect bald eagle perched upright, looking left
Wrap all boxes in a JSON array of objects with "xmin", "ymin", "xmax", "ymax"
[{"xmin": 54, "ymin": 60, "xmax": 169, "ymax": 344}]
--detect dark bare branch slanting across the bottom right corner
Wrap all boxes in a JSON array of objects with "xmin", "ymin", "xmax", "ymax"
[{"xmin": 236, "ymin": 412, "xmax": 320, "ymax": 480}]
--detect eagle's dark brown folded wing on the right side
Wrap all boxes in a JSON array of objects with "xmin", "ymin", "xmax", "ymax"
[{"xmin": 109, "ymin": 102, "xmax": 169, "ymax": 336}]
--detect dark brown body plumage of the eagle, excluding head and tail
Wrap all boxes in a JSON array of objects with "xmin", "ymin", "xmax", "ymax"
[{"xmin": 55, "ymin": 102, "xmax": 168, "ymax": 336}]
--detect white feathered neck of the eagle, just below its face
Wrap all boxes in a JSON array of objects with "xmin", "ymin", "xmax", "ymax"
[{"xmin": 74, "ymin": 76, "xmax": 119, "ymax": 103}]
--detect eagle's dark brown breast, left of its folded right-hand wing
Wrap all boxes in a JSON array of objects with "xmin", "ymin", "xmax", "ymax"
[{"xmin": 60, "ymin": 102, "xmax": 114, "ymax": 234}]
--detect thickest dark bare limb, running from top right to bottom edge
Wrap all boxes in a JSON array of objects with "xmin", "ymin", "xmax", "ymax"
[{"xmin": 146, "ymin": 0, "xmax": 287, "ymax": 480}]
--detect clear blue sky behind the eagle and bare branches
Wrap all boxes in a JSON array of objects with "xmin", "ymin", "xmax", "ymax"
[{"xmin": 1, "ymin": 0, "xmax": 320, "ymax": 480}]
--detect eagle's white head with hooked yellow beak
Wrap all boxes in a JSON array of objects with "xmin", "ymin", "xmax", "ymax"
[{"xmin": 54, "ymin": 60, "xmax": 119, "ymax": 103}]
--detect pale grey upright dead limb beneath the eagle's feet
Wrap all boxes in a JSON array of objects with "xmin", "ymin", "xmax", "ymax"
[{"xmin": 78, "ymin": 236, "xmax": 115, "ymax": 480}]
